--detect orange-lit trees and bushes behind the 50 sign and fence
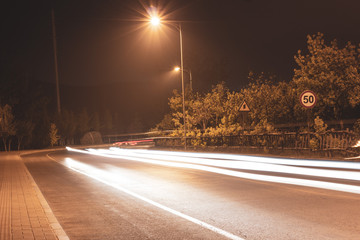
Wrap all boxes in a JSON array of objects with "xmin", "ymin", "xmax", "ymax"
[{"xmin": 153, "ymin": 33, "xmax": 360, "ymax": 149}]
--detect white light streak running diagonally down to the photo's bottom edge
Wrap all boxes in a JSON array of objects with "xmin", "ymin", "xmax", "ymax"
[{"xmin": 64, "ymin": 158, "xmax": 244, "ymax": 240}]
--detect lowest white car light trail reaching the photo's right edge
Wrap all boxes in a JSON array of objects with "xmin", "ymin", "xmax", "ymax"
[{"xmin": 67, "ymin": 148, "xmax": 360, "ymax": 194}]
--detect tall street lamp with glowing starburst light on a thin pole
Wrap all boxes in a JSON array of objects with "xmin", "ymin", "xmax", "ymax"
[{"xmin": 150, "ymin": 14, "xmax": 186, "ymax": 150}]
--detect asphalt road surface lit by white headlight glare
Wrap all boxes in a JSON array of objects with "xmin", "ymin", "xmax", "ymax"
[{"xmin": 23, "ymin": 148, "xmax": 360, "ymax": 240}]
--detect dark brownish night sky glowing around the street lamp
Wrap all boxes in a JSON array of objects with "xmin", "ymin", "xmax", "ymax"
[{"xmin": 0, "ymin": 0, "xmax": 360, "ymax": 129}]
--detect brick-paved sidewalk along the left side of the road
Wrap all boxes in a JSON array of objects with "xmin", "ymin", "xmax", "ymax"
[{"xmin": 0, "ymin": 153, "xmax": 69, "ymax": 240}]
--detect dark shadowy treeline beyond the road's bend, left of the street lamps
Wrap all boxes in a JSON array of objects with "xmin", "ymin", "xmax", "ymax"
[{"xmin": 0, "ymin": 76, "xmax": 145, "ymax": 151}]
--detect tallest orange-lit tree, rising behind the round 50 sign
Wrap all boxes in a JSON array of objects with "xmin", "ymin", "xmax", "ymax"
[{"xmin": 293, "ymin": 33, "xmax": 360, "ymax": 119}]
